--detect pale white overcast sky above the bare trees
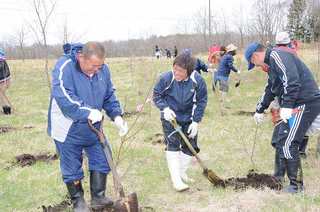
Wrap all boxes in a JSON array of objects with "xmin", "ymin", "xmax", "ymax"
[{"xmin": 0, "ymin": 0, "xmax": 252, "ymax": 44}]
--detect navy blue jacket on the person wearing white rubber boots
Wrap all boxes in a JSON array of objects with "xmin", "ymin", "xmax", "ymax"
[{"xmin": 153, "ymin": 71, "xmax": 208, "ymax": 122}]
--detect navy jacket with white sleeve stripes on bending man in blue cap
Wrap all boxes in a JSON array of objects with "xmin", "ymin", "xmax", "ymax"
[{"xmin": 256, "ymin": 48, "xmax": 320, "ymax": 113}]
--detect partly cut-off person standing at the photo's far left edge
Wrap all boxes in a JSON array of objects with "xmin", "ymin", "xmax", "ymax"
[{"xmin": 0, "ymin": 49, "xmax": 11, "ymax": 115}]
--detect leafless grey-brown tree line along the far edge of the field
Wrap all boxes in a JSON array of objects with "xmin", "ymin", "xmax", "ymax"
[{"xmin": 0, "ymin": 0, "xmax": 320, "ymax": 60}]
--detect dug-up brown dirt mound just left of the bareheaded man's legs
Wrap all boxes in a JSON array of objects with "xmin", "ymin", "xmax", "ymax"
[{"xmin": 15, "ymin": 153, "xmax": 58, "ymax": 167}]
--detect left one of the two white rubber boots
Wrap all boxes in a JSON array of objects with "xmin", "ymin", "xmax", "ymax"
[{"xmin": 166, "ymin": 151, "xmax": 189, "ymax": 191}]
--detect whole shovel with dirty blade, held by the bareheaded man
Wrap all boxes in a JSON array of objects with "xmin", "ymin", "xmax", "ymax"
[{"xmin": 88, "ymin": 118, "xmax": 139, "ymax": 212}]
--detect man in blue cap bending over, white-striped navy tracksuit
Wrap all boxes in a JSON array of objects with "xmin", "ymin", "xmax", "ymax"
[{"xmin": 245, "ymin": 42, "xmax": 320, "ymax": 193}]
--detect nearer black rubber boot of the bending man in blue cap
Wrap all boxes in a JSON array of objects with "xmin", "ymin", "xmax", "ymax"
[{"xmin": 285, "ymin": 159, "xmax": 303, "ymax": 194}]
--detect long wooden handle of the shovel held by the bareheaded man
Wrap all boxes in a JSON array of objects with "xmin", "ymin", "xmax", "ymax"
[{"xmin": 88, "ymin": 116, "xmax": 125, "ymax": 198}]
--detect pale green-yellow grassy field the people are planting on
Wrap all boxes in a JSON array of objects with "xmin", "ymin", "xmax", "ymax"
[{"xmin": 0, "ymin": 46, "xmax": 320, "ymax": 212}]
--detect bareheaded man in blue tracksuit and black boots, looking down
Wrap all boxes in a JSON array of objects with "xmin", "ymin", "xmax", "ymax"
[{"xmin": 48, "ymin": 42, "xmax": 128, "ymax": 211}]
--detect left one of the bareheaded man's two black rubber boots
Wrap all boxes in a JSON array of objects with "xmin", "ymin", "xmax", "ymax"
[{"xmin": 66, "ymin": 181, "xmax": 89, "ymax": 212}]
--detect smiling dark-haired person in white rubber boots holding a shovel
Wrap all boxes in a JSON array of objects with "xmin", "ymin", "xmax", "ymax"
[{"xmin": 153, "ymin": 52, "xmax": 207, "ymax": 191}]
